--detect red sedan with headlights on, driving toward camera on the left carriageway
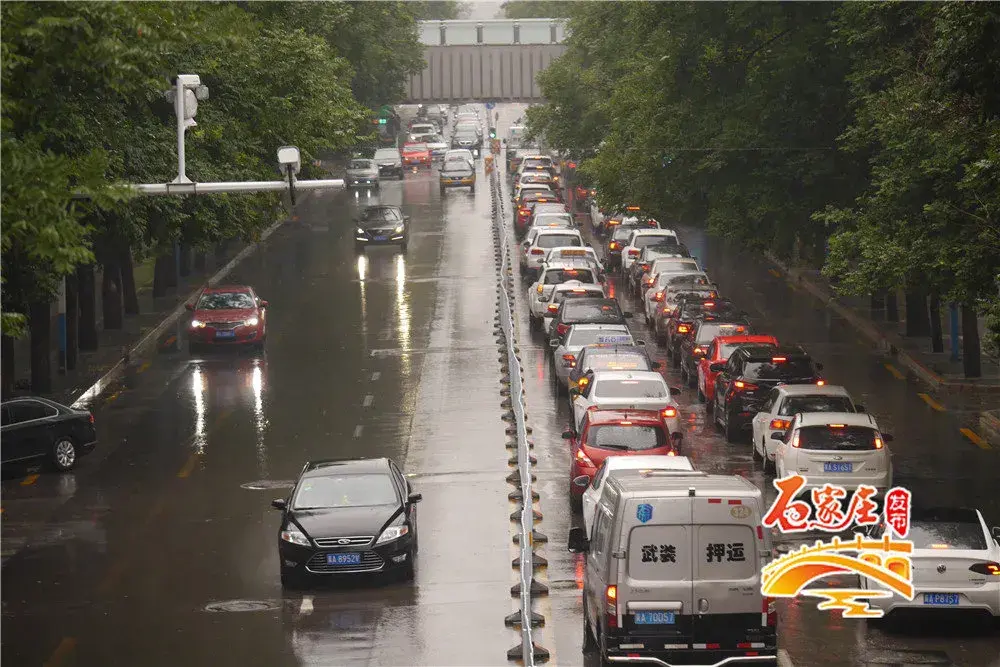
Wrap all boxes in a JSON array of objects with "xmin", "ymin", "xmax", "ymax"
[{"xmin": 185, "ymin": 285, "xmax": 267, "ymax": 352}]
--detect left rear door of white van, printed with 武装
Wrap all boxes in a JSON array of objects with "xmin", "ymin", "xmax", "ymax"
[{"xmin": 618, "ymin": 496, "xmax": 697, "ymax": 648}]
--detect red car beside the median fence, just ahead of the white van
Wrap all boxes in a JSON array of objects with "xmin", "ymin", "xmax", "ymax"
[{"xmin": 563, "ymin": 408, "xmax": 681, "ymax": 506}]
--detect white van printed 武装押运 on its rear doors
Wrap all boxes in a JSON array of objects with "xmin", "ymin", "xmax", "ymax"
[{"xmin": 570, "ymin": 470, "xmax": 777, "ymax": 667}]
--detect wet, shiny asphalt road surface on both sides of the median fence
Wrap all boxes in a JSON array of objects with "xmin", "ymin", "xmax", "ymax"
[{"xmin": 2, "ymin": 107, "xmax": 1000, "ymax": 667}]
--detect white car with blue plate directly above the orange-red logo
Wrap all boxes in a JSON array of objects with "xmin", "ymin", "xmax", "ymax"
[{"xmin": 771, "ymin": 412, "xmax": 892, "ymax": 495}]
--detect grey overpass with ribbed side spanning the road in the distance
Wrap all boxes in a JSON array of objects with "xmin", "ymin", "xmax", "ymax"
[{"xmin": 403, "ymin": 19, "xmax": 566, "ymax": 104}]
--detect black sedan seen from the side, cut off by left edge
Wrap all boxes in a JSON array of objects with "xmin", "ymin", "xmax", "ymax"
[{"xmin": 0, "ymin": 396, "xmax": 97, "ymax": 471}]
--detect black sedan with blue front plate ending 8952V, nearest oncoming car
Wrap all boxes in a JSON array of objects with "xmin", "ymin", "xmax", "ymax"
[{"xmin": 271, "ymin": 458, "xmax": 422, "ymax": 588}]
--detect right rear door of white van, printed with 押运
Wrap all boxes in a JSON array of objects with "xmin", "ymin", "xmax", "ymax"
[{"xmin": 692, "ymin": 495, "xmax": 774, "ymax": 650}]
